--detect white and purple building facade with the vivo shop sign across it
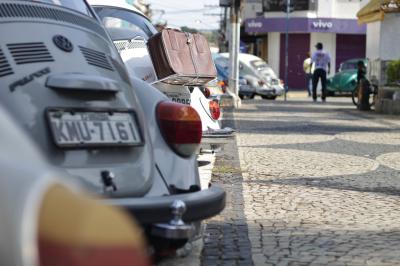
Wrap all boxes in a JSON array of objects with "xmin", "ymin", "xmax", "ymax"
[{"xmin": 242, "ymin": 0, "xmax": 366, "ymax": 89}]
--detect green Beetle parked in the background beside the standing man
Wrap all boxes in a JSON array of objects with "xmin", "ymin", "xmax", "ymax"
[{"xmin": 327, "ymin": 58, "xmax": 367, "ymax": 96}]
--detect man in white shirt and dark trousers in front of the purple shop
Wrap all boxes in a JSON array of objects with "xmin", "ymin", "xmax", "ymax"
[{"xmin": 311, "ymin": 42, "xmax": 331, "ymax": 102}]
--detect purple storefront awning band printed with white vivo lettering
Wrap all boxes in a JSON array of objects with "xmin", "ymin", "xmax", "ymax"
[{"xmin": 245, "ymin": 17, "xmax": 366, "ymax": 34}]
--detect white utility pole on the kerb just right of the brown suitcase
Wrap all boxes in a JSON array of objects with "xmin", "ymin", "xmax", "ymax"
[{"xmin": 229, "ymin": 0, "xmax": 241, "ymax": 108}]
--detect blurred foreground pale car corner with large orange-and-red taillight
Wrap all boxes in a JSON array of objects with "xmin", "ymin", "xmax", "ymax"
[{"xmin": 0, "ymin": 106, "xmax": 150, "ymax": 266}]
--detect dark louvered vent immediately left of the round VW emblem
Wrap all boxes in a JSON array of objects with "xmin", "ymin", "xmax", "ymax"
[{"xmin": 7, "ymin": 42, "xmax": 54, "ymax": 65}]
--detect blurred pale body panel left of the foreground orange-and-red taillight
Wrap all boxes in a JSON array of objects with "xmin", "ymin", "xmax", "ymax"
[{"xmin": 0, "ymin": 108, "xmax": 55, "ymax": 266}]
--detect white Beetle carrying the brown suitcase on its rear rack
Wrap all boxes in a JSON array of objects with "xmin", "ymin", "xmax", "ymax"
[{"xmin": 89, "ymin": 0, "xmax": 233, "ymax": 142}]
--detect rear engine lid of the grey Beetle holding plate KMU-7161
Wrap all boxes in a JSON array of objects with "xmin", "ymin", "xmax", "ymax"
[{"xmin": 0, "ymin": 0, "xmax": 153, "ymax": 197}]
